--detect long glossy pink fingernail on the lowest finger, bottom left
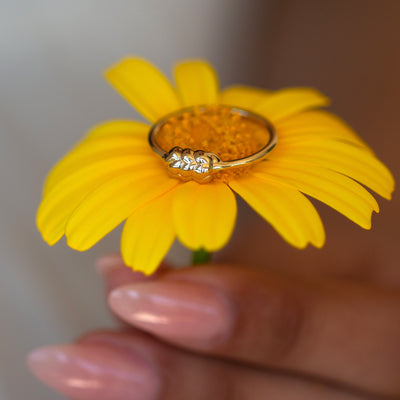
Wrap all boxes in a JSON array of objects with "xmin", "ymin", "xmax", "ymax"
[{"xmin": 28, "ymin": 345, "xmax": 159, "ymax": 400}]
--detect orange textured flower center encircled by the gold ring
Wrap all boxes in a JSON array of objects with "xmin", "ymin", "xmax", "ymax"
[{"xmin": 157, "ymin": 105, "xmax": 270, "ymax": 182}]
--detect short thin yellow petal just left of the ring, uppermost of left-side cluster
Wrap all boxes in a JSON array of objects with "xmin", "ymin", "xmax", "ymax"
[{"xmin": 84, "ymin": 120, "xmax": 150, "ymax": 140}]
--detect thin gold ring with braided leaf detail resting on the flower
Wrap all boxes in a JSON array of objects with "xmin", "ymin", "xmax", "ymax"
[{"xmin": 149, "ymin": 107, "xmax": 278, "ymax": 181}]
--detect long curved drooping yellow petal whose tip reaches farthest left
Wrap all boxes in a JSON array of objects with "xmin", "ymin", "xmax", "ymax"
[{"xmin": 36, "ymin": 156, "xmax": 152, "ymax": 245}]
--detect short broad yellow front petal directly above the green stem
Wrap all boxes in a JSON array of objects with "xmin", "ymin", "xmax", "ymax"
[{"xmin": 173, "ymin": 181, "xmax": 237, "ymax": 251}]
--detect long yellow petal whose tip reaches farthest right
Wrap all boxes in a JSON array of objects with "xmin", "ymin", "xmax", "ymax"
[{"xmin": 269, "ymin": 140, "xmax": 394, "ymax": 199}]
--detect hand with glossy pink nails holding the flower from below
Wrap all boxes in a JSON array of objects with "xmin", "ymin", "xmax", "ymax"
[{"xmin": 29, "ymin": 257, "xmax": 400, "ymax": 400}]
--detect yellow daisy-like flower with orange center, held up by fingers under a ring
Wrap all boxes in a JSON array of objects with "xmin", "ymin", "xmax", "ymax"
[{"xmin": 37, "ymin": 58, "xmax": 394, "ymax": 274}]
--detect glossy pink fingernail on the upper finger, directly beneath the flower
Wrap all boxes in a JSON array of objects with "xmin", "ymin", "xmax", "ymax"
[{"xmin": 109, "ymin": 281, "xmax": 233, "ymax": 345}]
